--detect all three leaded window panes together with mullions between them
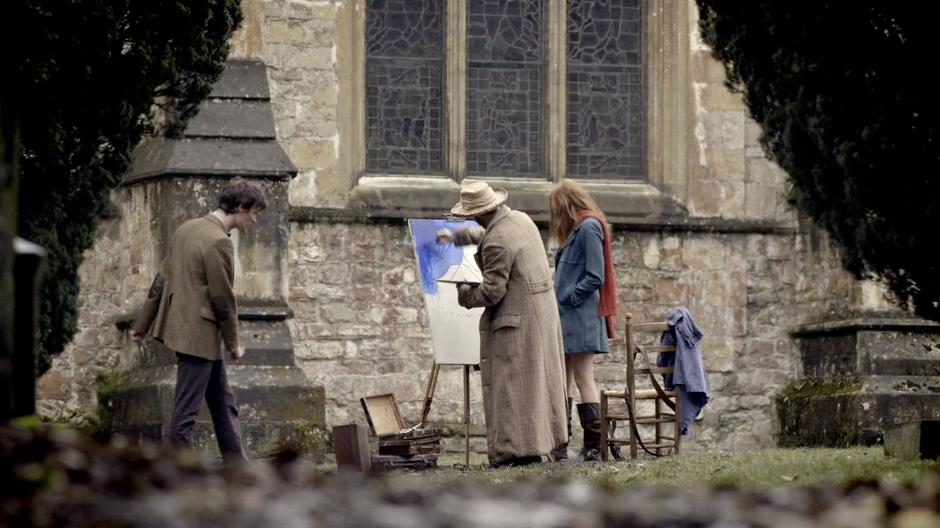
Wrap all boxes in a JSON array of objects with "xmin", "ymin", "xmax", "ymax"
[{"xmin": 365, "ymin": 0, "xmax": 647, "ymax": 180}]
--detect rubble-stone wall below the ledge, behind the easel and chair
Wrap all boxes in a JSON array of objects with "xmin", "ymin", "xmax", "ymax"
[{"xmin": 290, "ymin": 217, "xmax": 853, "ymax": 449}]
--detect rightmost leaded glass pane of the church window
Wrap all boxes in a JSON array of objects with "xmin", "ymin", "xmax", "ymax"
[{"xmin": 566, "ymin": 0, "xmax": 645, "ymax": 179}]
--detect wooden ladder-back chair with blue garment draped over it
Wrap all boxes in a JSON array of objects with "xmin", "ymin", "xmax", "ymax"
[{"xmin": 601, "ymin": 314, "xmax": 681, "ymax": 460}]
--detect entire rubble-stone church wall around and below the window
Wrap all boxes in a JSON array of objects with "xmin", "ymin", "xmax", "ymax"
[{"xmin": 39, "ymin": 0, "xmax": 872, "ymax": 449}]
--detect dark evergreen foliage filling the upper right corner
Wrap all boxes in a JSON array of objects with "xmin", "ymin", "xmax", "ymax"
[{"xmin": 697, "ymin": 0, "xmax": 940, "ymax": 321}]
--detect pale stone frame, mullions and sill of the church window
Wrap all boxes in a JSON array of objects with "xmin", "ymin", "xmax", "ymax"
[{"xmin": 336, "ymin": 0, "xmax": 694, "ymax": 221}]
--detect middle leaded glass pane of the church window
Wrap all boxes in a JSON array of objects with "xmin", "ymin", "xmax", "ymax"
[{"xmin": 467, "ymin": 0, "xmax": 545, "ymax": 176}]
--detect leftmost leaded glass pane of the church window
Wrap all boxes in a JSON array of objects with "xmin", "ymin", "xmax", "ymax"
[{"xmin": 366, "ymin": 0, "xmax": 444, "ymax": 173}]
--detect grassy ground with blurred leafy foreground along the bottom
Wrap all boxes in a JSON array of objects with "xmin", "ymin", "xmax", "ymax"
[{"xmin": 0, "ymin": 427, "xmax": 940, "ymax": 528}]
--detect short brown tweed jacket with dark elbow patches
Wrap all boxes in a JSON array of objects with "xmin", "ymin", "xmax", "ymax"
[{"xmin": 134, "ymin": 214, "xmax": 238, "ymax": 360}]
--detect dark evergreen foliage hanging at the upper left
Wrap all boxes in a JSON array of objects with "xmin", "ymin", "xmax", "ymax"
[{"xmin": 7, "ymin": 0, "xmax": 241, "ymax": 373}]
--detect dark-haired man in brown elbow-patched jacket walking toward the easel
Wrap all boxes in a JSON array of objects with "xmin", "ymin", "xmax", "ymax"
[{"xmin": 131, "ymin": 180, "xmax": 267, "ymax": 460}]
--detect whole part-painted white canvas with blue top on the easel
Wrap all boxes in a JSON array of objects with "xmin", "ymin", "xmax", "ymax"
[{"xmin": 408, "ymin": 219, "xmax": 483, "ymax": 365}]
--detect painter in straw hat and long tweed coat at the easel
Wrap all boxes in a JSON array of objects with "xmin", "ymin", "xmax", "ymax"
[{"xmin": 439, "ymin": 182, "xmax": 568, "ymax": 466}]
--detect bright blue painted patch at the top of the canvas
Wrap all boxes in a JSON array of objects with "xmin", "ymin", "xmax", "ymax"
[{"xmin": 409, "ymin": 219, "xmax": 478, "ymax": 295}]
